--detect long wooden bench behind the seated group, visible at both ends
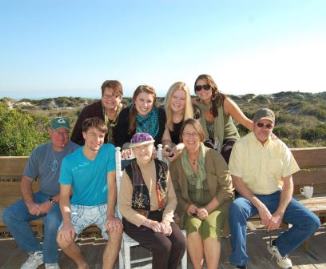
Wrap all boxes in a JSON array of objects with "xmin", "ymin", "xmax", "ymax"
[{"xmin": 0, "ymin": 147, "xmax": 326, "ymax": 236}]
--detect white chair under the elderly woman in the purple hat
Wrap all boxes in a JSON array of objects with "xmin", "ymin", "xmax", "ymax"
[{"xmin": 115, "ymin": 145, "xmax": 187, "ymax": 269}]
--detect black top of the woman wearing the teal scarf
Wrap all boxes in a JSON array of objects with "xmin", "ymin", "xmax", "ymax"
[{"xmin": 113, "ymin": 106, "xmax": 166, "ymax": 147}]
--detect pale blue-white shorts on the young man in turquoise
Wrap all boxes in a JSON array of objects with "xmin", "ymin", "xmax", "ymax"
[{"xmin": 59, "ymin": 204, "xmax": 108, "ymax": 239}]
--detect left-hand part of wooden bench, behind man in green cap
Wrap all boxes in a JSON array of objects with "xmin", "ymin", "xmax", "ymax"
[{"xmin": 0, "ymin": 156, "xmax": 43, "ymax": 237}]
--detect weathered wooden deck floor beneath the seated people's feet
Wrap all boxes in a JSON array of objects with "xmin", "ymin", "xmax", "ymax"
[{"xmin": 0, "ymin": 224, "xmax": 326, "ymax": 269}]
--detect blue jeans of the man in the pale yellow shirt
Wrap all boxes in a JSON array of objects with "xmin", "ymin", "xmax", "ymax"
[{"xmin": 229, "ymin": 191, "xmax": 320, "ymax": 265}]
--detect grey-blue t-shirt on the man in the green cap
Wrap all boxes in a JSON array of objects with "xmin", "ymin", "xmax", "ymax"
[{"xmin": 24, "ymin": 141, "xmax": 79, "ymax": 196}]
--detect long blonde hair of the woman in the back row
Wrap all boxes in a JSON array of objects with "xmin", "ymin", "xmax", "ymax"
[{"xmin": 164, "ymin": 81, "xmax": 194, "ymax": 131}]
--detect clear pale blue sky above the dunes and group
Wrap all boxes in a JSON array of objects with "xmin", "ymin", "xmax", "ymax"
[{"xmin": 0, "ymin": 0, "xmax": 326, "ymax": 98}]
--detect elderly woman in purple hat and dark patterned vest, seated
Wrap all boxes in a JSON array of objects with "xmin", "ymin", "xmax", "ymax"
[{"xmin": 119, "ymin": 133, "xmax": 185, "ymax": 269}]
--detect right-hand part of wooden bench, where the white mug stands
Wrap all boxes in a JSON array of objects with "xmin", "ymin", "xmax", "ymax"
[{"xmin": 248, "ymin": 147, "xmax": 326, "ymax": 230}]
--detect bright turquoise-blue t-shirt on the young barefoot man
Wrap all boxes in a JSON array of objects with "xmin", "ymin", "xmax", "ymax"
[{"xmin": 59, "ymin": 144, "xmax": 115, "ymax": 206}]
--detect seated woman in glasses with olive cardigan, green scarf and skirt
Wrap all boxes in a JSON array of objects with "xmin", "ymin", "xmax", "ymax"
[{"xmin": 170, "ymin": 119, "xmax": 233, "ymax": 269}]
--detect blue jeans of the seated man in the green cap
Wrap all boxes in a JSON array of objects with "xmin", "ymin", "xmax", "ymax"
[{"xmin": 3, "ymin": 192, "xmax": 62, "ymax": 263}]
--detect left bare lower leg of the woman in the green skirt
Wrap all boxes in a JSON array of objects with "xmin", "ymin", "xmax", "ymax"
[{"xmin": 187, "ymin": 232, "xmax": 204, "ymax": 269}]
